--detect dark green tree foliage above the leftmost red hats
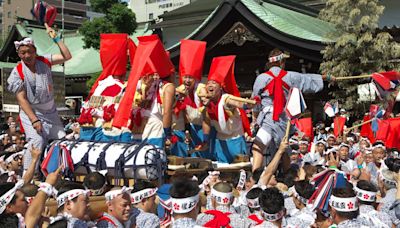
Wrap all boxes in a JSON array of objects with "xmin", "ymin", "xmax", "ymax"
[{"xmin": 79, "ymin": 0, "xmax": 137, "ymax": 49}]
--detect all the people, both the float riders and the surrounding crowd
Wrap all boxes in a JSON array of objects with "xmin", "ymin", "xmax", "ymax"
[{"xmin": 0, "ymin": 23, "xmax": 400, "ymax": 228}]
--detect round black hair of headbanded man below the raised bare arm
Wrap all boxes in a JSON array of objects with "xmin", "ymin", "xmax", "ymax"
[{"xmin": 259, "ymin": 188, "xmax": 285, "ymax": 214}]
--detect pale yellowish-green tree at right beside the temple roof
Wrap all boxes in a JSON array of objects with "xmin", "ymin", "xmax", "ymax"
[{"xmin": 319, "ymin": 0, "xmax": 400, "ymax": 116}]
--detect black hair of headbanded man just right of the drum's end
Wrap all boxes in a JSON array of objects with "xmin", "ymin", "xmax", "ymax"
[{"xmin": 169, "ymin": 178, "xmax": 200, "ymax": 199}]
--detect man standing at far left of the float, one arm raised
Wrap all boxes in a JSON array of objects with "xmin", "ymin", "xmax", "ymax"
[{"xmin": 7, "ymin": 26, "xmax": 71, "ymax": 170}]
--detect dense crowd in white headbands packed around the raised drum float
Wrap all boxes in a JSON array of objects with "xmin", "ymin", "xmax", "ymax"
[{"xmin": 0, "ymin": 113, "xmax": 400, "ymax": 228}]
